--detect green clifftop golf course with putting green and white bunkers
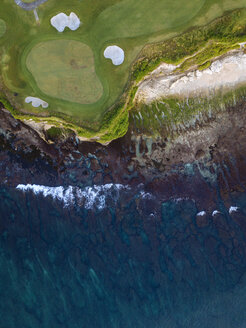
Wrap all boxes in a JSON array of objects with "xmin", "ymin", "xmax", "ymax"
[{"xmin": 0, "ymin": 0, "xmax": 246, "ymax": 142}]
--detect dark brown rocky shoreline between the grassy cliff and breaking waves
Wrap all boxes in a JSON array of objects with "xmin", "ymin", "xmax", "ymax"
[{"xmin": 0, "ymin": 97, "xmax": 246, "ymax": 208}]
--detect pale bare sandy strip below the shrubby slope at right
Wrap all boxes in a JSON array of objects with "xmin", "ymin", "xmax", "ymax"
[{"xmin": 135, "ymin": 52, "xmax": 246, "ymax": 103}]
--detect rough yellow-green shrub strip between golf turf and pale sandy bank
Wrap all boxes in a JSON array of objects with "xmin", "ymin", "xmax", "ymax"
[{"xmin": 132, "ymin": 9, "xmax": 246, "ymax": 81}]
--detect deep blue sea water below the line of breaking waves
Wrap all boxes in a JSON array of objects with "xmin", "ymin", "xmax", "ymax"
[{"xmin": 0, "ymin": 182, "xmax": 246, "ymax": 328}]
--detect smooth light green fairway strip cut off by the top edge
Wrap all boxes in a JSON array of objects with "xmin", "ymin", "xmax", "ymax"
[{"xmin": 94, "ymin": 0, "xmax": 205, "ymax": 39}]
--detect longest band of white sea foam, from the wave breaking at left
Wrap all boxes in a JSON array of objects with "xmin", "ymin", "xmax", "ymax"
[{"xmin": 16, "ymin": 183, "xmax": 130, "ymax": 210}]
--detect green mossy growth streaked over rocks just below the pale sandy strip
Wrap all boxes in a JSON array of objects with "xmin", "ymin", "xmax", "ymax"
[{"xmin": 130, "ymin": 87, "xmax": 246, "ymax": 137}]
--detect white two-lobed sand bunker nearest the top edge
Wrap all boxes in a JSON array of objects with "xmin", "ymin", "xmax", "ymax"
[{"xmin": 50, "ymin": 13, "xmax": 80, "ymax": 32}]
